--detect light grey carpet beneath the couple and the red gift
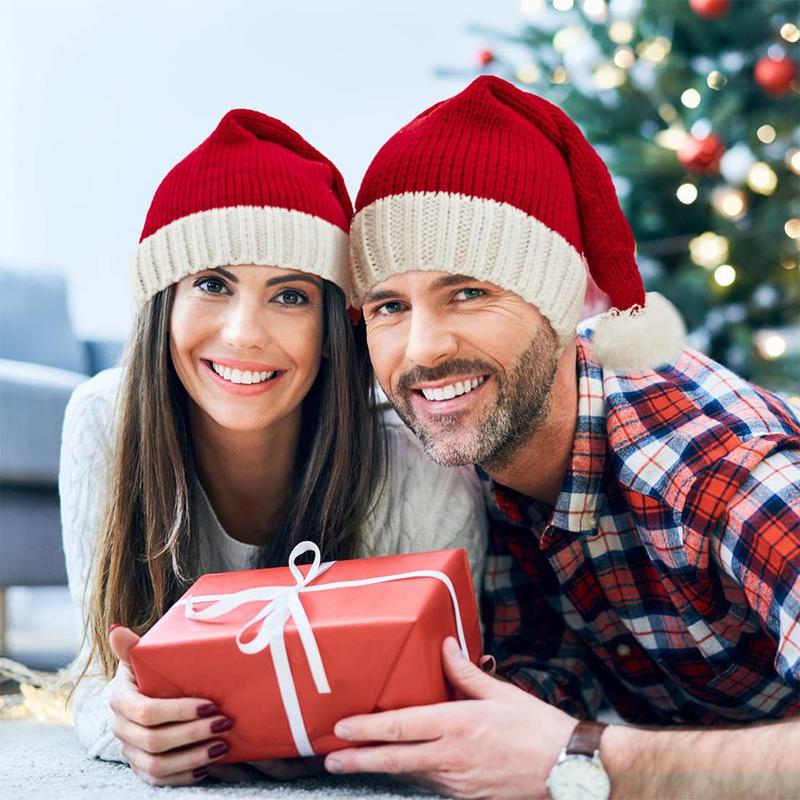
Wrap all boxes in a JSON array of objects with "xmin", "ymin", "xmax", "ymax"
[{"xmin": 0, "ymin": 720, "xmax": 432, "ymax": 800}]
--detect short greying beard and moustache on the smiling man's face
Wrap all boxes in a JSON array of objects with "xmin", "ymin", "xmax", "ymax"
[{"xmin": 387, "ymin": 325, "xmax": 558, "ymax": 472}]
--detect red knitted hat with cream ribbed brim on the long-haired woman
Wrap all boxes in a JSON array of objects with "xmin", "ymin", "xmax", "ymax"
[{"xmin": 133, "ymin": 109, "xmax": 353, "ymax": 306}]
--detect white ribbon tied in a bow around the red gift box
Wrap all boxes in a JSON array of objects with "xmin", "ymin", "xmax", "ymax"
[{"xmin": 182, "ymin": 542, "xmax": 469, "ymax": 756}]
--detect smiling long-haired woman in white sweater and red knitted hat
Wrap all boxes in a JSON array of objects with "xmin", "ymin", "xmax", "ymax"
[{"xmin": 60, "ymin": 110, "xmax": 485, "ymax": 785}]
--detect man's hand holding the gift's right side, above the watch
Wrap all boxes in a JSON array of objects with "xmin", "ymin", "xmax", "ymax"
[{"xmin": 325, "ymin": 638, "xmax": 577, "ymax": 798}]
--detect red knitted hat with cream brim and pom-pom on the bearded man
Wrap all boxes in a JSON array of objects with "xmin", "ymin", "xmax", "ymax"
[{"xmin": 350, "ymin": 76, "xmax": 685, "ymax": 370}]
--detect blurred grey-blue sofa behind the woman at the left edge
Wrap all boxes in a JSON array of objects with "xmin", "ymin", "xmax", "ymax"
[{"xmin": 0, "ymin": 268, "xmax": 122, "ymax": 654}]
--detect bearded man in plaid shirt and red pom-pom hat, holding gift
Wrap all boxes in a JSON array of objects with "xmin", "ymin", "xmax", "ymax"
[{"xmin": 326, "ymin": 77, "xmax": 800, "ymax": 800}]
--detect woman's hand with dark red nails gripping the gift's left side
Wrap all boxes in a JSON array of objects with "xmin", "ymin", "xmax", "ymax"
[{"xmin": 109, "ymin": 626, "xmax": 233, "ymax": 786}]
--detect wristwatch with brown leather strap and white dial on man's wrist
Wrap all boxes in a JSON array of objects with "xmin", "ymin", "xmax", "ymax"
[{"xmin": 545, "ymin": 720, "xmax": 611, "ymax": 800}]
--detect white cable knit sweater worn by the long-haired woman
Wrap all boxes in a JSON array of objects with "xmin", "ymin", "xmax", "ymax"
[{"xmin": 59, "ymin": 369, "xmax": 486, "ymax": 761}]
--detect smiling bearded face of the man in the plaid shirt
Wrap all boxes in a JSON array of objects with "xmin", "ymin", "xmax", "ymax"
[{"xmin": 363, "ymin": 272, "xmax": 558, "ymax": 469}]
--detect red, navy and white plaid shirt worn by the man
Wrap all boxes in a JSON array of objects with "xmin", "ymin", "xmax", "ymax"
[{"xmin": 481, "ymin": 337, "xmax": 800, "ymax": 725}]
